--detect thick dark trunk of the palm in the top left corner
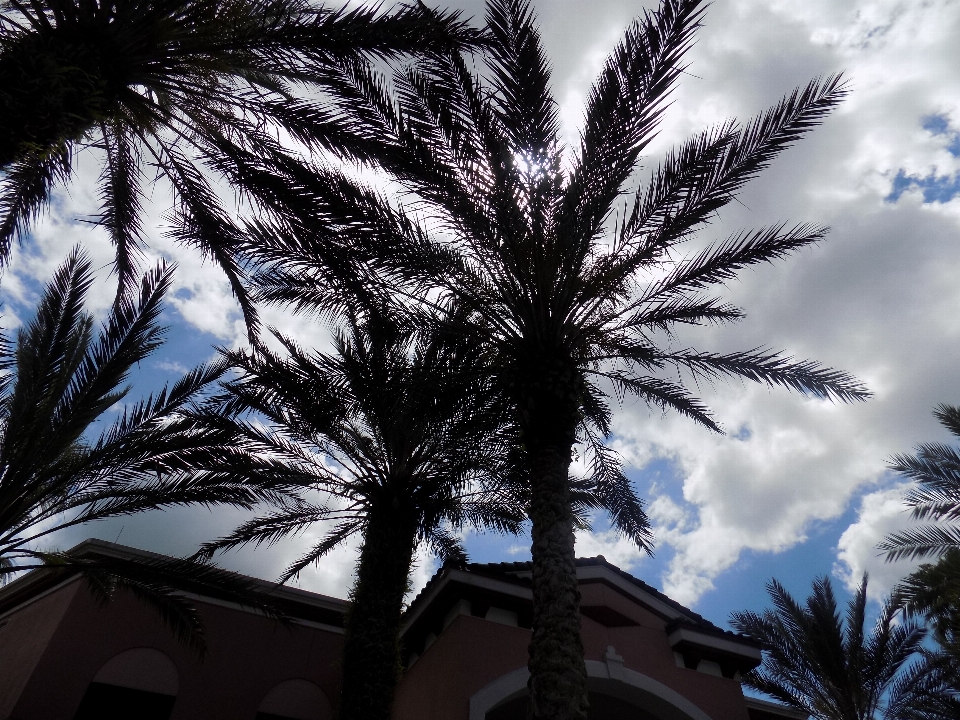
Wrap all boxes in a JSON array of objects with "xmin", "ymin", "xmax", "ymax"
[{"xmin": 0, "ymin": 34, "xmax": 107, "ymax": 168}]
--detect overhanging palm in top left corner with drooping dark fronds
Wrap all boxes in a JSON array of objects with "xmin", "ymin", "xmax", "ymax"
[{"xmin": 0, "ymin": 0, "xmax": 478, "ymax": 331}]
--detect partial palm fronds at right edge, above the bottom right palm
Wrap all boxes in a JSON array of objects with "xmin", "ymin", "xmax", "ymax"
[{"xmin": 879, "ymin": 404, "xmax": 960, "ymax": 561}]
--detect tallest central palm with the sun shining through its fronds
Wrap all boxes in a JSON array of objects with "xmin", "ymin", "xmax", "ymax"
[{"xmin": 250, "ymin": 0, "xmax": 868, "ymax": 720}]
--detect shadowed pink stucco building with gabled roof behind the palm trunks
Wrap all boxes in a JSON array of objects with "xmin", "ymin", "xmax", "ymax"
[{"xmin": 0, "ymin": 540, "xmax": 805, "ymax": 720}]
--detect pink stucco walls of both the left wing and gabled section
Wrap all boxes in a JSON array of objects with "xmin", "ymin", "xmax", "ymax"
[{"xmin": 0, "ymin": 568, "xmax": 748, "ymax": 720}]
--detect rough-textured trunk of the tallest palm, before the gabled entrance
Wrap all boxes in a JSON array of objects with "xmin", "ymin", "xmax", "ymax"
[{"xmin": 521, "ymin": 368, "xmax": 588, "ymax": 720}]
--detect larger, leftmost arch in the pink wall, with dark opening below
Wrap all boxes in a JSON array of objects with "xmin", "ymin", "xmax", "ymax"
[{"xmin": 74, "ymin": 647, "xmax": 180, "ymax": 720}]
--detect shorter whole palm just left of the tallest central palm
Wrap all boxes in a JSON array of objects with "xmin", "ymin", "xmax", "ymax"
[{"xmin": 197, "ymin": 312, "xmax": 524, "ymax": 720}]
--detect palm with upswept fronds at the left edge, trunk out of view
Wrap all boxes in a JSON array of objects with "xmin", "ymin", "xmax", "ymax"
[{"xmin": 0, "ymin": 250, "xmax": 300, "ymax": 650}]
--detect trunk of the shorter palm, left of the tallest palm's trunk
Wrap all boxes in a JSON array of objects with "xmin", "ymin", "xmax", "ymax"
[{"xmin": 339, "ymin": 500, "xmax": 416, "ymax": 720}]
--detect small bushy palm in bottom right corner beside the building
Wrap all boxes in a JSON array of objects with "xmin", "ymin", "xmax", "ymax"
[{"xmin": 730, "ymin": 576, "xmax": 960, "ymax": 720}]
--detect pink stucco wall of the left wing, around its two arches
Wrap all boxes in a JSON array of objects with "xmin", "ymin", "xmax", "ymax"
[{"xmin": 0, "ymin": 583, "xmax": 343, "ymax": 720}]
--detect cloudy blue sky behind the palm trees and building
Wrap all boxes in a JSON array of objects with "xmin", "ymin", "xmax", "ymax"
[{"xmin": 7, "ymin": 0, "xmax": 960, "ymax": 624}]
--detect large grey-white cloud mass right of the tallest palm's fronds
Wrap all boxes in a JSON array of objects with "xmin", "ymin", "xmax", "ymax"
[{"xmin": 588, "ymin": 0, "xmax": 960, "ymax": 603}]
